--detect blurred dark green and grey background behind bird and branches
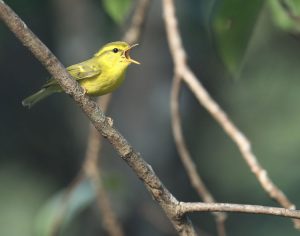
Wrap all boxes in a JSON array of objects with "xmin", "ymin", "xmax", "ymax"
[{"xmin": 0, "ymin": 0, "xmax": 300, "ymax": 236}]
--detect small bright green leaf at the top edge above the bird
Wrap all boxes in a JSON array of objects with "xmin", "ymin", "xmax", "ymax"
[{"xmin": 103, "ymin": 0, "xmax": 132, "ymax": 24}]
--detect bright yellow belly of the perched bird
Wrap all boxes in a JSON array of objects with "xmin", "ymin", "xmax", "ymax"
[{"xmin": 80, "ymin": 73, "xmax": 125, "ymax": 96}]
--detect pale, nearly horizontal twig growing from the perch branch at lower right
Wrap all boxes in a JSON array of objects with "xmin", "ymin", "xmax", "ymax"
[{"xmin": 178, "ymin": 202, "xmax": 300, "ymax": 219}]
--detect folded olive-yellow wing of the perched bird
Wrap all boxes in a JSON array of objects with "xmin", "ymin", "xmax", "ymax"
[{"xmin": 43, "ymin": 59, "xmax": 101, "ymax": 87}]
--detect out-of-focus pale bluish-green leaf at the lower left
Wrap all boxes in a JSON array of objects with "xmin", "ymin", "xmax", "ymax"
[{"xmin": 35, "ymin": 180, "xmax": 95, "ymax": 236}]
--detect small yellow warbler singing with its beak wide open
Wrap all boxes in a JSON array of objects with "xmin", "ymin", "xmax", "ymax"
[{"xmin": 22, "ymin": 41, "xmax": 140, "ymax": 108}]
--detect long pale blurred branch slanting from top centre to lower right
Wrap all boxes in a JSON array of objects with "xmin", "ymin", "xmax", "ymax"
[{"xmin": 163, "ymin": 0, "xmax": 300, "ymax": 228}]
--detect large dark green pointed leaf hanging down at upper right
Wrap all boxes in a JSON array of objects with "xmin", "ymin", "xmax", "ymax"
[{"xmin": 212, "ymin": 0, "xmax": 264, "ymax": 76}]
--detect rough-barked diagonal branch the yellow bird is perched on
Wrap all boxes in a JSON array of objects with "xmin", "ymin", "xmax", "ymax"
[{"xmin": 0, "ymin": 0, "xmax": 196, "ymax": 235}]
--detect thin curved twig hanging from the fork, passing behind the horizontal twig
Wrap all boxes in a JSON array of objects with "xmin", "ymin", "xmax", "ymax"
[{"xmin": 171, "ymin": 75, "xmax": 226, "ymax": 236}]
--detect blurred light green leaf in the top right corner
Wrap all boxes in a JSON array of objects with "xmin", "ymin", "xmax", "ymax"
[{"xmin": 269, "ymin": 0, "xmax": 300, "ymax": 33}]
